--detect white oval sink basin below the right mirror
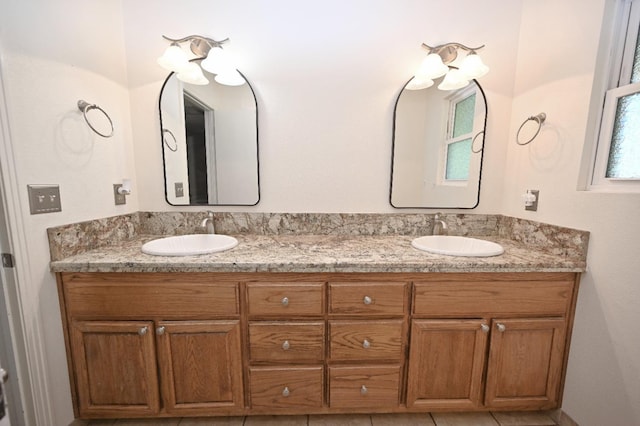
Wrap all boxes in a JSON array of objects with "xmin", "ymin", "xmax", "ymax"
[{"xmin": 411, "ymin": 235, "xmax": 504, "ymax": 257}]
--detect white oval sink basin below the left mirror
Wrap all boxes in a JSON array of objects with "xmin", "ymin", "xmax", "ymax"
[{"xmin": 142, "ymin": 234, "xmax": 238, "ymax": 256}]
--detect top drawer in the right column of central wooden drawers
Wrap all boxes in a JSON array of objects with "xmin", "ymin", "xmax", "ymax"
[{"xmin": 329, "ymin": 282, "xmax": 407, "ymax": 315}]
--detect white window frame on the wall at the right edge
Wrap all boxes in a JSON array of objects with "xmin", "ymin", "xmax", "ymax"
[{"xmin": 588, "ymin": 0, "xmax": 640, "ymax": 192}]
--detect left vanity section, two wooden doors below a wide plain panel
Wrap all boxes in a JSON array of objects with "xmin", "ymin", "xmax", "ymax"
[{"xmin": 59, "ymin": 273, "xmax": 244, "ymax": 418}]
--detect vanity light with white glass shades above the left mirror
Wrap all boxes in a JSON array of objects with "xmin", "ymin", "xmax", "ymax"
[{"xmin": 158, "ymin": 35, "xmax": 245, "ymax": 86}]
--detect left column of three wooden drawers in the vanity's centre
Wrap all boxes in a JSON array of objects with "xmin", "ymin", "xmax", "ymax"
[{"xmin": 247, "ymin": 282, "xmax": 326, "ymax": 410}]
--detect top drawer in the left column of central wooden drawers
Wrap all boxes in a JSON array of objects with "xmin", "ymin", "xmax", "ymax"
[{"xmin": 247, "ymin": 283, "xmax": 324, "ymax": 316}]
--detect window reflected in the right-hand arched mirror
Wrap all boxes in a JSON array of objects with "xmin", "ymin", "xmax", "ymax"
[{"xmin": 444, "ymin": 90, "xmax": 476, "ymax": 183}]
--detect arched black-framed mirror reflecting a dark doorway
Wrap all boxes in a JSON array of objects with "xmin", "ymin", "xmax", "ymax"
[{"xmin": 160, "ymin": 61, "xmax": 260, "ymax": 206}]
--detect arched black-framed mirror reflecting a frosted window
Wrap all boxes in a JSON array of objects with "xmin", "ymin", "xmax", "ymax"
[{"xmin": 389, "ymin": 80, "xmax": 487, "ymax": 209}]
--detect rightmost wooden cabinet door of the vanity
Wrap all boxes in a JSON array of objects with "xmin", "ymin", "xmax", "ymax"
[{"xmin": 485, "ymin": 318, "xmax": 566, "ymax": 409}]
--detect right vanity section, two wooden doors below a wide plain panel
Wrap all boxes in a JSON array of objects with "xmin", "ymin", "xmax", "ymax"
[{"xmin": 407, "ymin": 274, "xmax": 577, "ymax": 410}]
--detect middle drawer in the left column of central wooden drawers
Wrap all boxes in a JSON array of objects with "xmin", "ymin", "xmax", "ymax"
[{"xmin": 249, "ymin": 321, "xmax": 324, "ymax": 361}]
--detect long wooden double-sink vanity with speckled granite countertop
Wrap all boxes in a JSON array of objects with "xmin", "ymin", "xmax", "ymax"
[{"xmin": 52, "ymin": 211, "xmax": 584, "ymax": 418}]
